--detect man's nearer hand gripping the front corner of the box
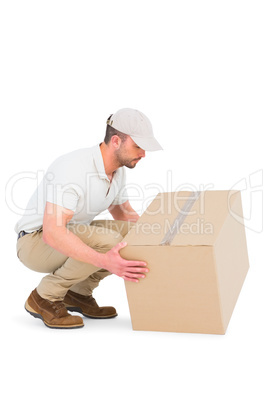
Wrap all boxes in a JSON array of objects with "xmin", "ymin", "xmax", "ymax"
[{"xmin": 102, "ymin": 242, "xmax": 149, "ymax": 282}]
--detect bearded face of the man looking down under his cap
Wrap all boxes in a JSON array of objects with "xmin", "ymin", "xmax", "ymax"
[{"xmin": 115, "ymin": 136, "xmax": 145, "ymax": 169}]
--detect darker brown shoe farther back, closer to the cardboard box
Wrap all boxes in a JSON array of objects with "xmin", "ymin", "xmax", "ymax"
[{"xmin": 63, "ymin": 290, "xmax": 117, "ymax": 318}]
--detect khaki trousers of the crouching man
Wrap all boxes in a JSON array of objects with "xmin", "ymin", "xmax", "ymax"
[{"xmin": 17, "ymin": 220, "xmax": 135, "ymax": 301}]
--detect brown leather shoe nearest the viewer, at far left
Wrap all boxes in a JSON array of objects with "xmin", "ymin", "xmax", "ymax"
[{"xmin": 25, "ymin": 289, "xmax": 84, "ymax": 328}]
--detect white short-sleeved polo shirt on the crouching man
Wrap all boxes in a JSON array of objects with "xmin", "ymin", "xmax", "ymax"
[{"xmin": 15, "ymin": 145, "xmax": 128, "ymax": 233}]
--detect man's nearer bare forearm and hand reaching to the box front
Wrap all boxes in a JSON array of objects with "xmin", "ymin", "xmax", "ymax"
[{"xmin": 43, "ymin": 202, "xmax": 148, "ymax": 282}]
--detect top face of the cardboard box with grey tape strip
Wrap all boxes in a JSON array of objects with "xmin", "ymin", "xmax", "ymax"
[{"xmin": 124, "ymin": 190, "xmax": 240, "ymax": 246}]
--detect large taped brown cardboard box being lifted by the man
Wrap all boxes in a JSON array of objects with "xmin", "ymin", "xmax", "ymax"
[{"xmin": 121, "ymin": 191, "xmax": 249, "ymax": 334}]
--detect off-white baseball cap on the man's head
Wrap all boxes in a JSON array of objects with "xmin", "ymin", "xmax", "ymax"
[{"xmin": 107, "ymin": 108, "xmax": 163, "ymax": 151}]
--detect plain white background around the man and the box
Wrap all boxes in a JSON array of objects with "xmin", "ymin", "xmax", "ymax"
[{"xmin": 0, "ymin": 0, "xmax": 268, "ymax": 402}]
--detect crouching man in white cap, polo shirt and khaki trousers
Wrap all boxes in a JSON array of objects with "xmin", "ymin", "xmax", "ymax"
[{"xmin": 15, "ymin": 109, "xmax": 162, "ymax": 328}]
